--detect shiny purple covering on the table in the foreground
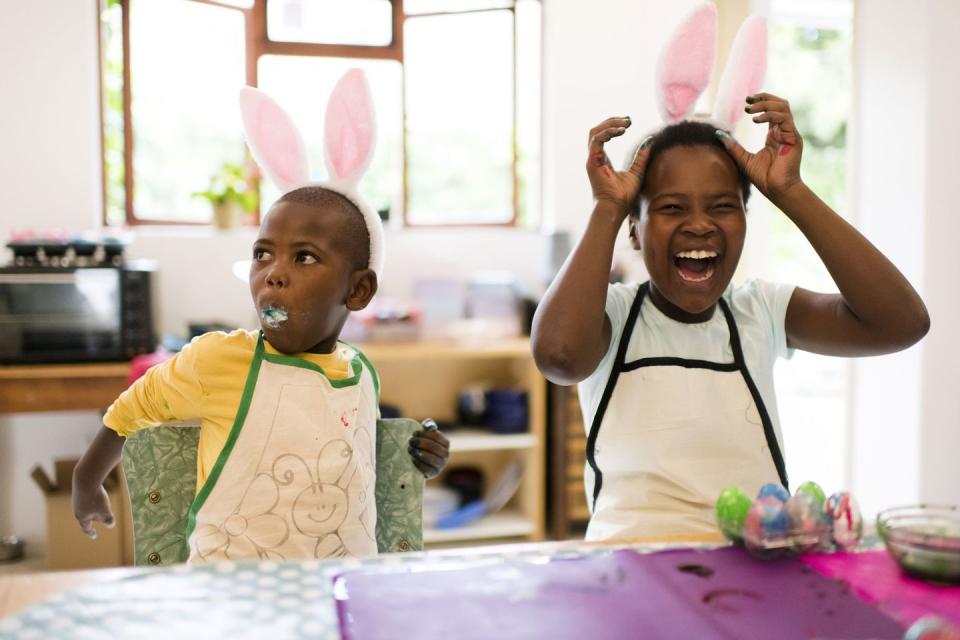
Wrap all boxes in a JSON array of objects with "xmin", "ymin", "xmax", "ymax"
[{"xmin": 334, "ymin": 548, "xmax": 904, "ymax": 640}]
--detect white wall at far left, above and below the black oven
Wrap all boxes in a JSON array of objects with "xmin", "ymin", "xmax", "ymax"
[{"xmin": 0, "ymin": 0, "xmax": 101, "ymax": 553}]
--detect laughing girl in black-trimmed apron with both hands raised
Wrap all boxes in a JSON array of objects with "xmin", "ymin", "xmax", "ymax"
[{"xmin": 532, "ymin": 7, "xmax": 930, "ymax": 540}]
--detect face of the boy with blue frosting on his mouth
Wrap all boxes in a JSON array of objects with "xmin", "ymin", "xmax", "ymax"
[{"xmin": 250, "ymin": 202, "xmax": 377, "ymax": 353}]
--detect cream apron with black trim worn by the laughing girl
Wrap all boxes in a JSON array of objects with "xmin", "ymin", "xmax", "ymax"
[{"xmin": 584, "ymin": 283, "xmax": 787, "ymax": 540}]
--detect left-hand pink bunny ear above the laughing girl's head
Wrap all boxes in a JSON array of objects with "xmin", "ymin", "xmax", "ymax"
[{"xmin": 656, "ymin": 2, "xmax": 717, "ymax": 123}]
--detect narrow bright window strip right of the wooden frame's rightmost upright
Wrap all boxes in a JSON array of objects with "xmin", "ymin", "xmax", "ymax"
[{"xmin": 516, "ymin": 0, "xmax": 542, "ymax": 227}]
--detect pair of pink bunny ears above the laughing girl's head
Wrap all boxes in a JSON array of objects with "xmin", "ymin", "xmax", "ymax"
[{"xmin": 656, "ymin": 2, "xmax": 767, "ymax": 131}]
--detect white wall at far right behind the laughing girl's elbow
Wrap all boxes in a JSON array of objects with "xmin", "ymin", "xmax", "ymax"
[{"xmin": 853, "ymin": 0, "xmax": 960, "ymax": 511}]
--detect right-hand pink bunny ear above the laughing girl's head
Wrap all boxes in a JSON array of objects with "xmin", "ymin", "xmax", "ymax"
[{"xmin": 713, "ymin": 16, "xmax": 767, "ymax": 130}]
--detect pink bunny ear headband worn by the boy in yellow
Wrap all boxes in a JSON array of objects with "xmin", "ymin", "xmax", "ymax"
[{"xmin": 240, "ymin": 69, "xmax": 383, "ymax": 275}]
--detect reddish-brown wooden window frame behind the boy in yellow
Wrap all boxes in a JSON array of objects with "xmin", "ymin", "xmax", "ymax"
[{"xmin": 95, "ymin": 0, "xmax": 543, "ymax": 228}]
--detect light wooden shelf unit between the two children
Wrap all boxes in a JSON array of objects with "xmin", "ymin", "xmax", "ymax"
[{"xmin": 357, "ymin": 338, "xmax": 547, "ymax": 548}]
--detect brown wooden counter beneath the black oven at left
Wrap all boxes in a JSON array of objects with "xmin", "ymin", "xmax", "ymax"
[{"xmin": 0, "ymin": 362, "xmax": 130, "ymax": 414}]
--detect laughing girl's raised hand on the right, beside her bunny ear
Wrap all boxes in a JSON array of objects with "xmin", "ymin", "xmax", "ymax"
[{"xmin": 718, "ymin": 93, "xmax": 803, "ymax": 204}]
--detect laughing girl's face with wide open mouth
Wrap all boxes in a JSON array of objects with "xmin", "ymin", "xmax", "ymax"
[{"xmin": 630, "ymin": 145, "xmax": 747, "ymax": 322}]
